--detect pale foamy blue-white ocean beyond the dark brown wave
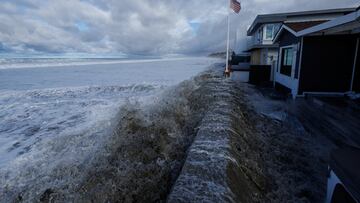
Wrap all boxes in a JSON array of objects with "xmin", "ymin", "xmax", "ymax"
[{"xmin": 0, "ymin": 58, "xmax": 217, "ymax": 202}]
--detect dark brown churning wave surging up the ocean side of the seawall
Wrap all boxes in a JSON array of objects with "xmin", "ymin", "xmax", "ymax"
[{"xmin": 66, "ymin": 68, "xmax": 222, "ymax": 202}]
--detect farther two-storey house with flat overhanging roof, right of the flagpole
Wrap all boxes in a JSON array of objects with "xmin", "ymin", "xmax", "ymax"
[{"xmin": 247, "ymin": 8, "xmax": 355, "ymax": 71}]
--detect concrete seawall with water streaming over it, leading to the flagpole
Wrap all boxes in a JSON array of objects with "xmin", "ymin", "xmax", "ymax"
[{"xmin": 168, "ymin": 68, "xmax": 265, "ymax": 202}]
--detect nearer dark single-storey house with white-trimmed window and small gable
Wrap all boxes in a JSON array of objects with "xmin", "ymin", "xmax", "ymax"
[{"xmin": 273, "ymin": 8, "xmax": 360, "ymax": 98}]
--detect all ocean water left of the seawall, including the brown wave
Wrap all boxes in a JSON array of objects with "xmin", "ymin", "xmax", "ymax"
[{"xmin": 0, "ymin": 58, "xmax": 219, "ymax": 202}]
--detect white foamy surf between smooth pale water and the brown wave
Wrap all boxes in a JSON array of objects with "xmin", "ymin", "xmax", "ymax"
[{"xmin": 0, "ymin": 84, "xmax": 162, "ymax": 167}]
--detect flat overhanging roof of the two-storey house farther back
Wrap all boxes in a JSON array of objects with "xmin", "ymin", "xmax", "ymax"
[{"xmin": 247, "ymin": 8, "xmax": 357, "ymax": 36}]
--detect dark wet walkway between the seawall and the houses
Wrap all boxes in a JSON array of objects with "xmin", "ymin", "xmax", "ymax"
[{"xmin": 239, "ymin": 83, "xmax": 360, "ymax": 202}]
